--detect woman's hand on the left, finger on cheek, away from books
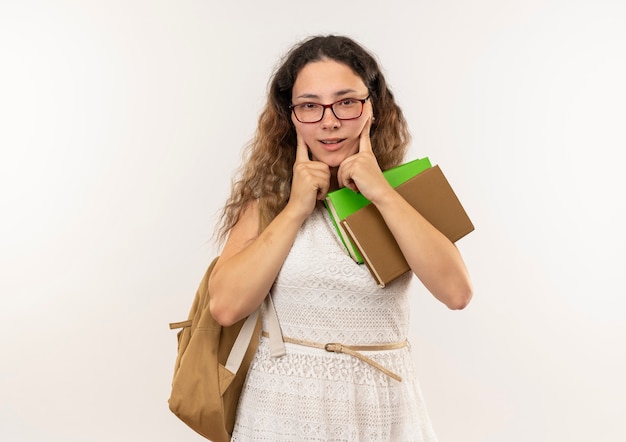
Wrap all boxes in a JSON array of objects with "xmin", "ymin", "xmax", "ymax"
[{"xmin": 288, "ymin": 134, "xmax": 330, "ymax": 217}]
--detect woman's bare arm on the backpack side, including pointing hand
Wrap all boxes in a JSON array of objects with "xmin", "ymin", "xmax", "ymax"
[{"xmin": 209, "ymin": 137, "xmax": 330, "ymax": 325}]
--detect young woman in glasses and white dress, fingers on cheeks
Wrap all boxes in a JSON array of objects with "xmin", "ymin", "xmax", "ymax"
[{"xmin": 210, "ymin": 35, "xmax": 472, "ymax": 441}]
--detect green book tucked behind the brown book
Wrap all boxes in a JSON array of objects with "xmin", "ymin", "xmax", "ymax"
[{"xmin": 324, "ymin": 157, "xmax": 431, "ymax": 264}]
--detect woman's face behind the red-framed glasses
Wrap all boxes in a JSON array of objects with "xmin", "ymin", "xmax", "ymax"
[{"xmin": 291, "ymin": 60, "xmax": 372, "ymax": 167}]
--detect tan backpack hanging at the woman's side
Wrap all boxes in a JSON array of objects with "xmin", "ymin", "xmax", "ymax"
[{"xmin": 168, "ymin": 258, "xmax": 260, "ymax": 442}]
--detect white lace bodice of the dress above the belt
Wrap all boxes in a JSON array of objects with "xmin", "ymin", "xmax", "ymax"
[{"xmin": 260, "ymin": 207, "xmax": 412, "ymax": 344}]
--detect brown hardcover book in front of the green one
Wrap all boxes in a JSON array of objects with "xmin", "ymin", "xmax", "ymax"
[{"xmin": 341, "ymin": 166, "xmax": 474, "ymax": 287}]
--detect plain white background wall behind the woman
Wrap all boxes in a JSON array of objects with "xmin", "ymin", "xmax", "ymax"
[{"xmin": 0, "ymin": 0, "xmax": 626, "ymax": 442}]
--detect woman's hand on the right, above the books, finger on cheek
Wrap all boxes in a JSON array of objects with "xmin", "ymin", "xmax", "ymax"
[{"xmin": 337, "ymin": 116, "xmax": 391, "ymax": 202}]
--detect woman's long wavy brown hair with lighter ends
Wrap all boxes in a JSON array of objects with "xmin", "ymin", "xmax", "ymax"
[{"xmin": 217, "ymin": 35, "xmax": 410, "ymax": 243}]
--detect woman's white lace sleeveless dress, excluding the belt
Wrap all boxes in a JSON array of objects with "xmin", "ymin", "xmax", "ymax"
[{"xmin": 232, "ymin": 207, "xmax": 436, "ymax": 442}]
